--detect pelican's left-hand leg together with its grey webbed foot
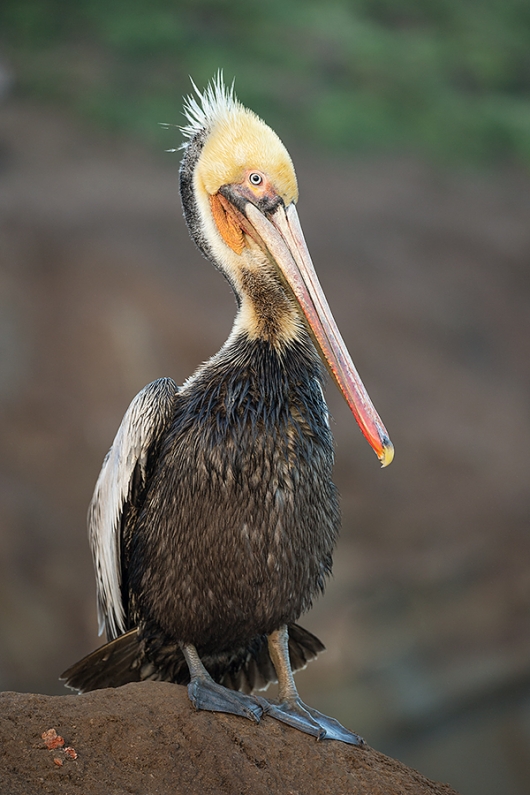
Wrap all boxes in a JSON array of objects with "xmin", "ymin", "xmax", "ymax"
[{"xmin": 181, "ymin": 644, "xmax": 263, "ymax": 723}]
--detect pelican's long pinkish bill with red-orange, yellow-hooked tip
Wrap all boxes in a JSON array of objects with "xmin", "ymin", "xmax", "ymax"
[{"xmin": 241, "ymin": 202, "xmax": 394, "ymax": 467}]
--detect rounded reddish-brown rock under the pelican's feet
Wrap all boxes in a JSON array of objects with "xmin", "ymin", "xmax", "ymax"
[{"xmin": 0, "ymin": 682, "xmax": 457, "ymax": 795}]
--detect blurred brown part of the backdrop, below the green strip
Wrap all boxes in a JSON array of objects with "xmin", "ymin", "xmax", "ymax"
[{"xmin": 0, "ymin": 99, "xmax": 530, "ymax": 795}]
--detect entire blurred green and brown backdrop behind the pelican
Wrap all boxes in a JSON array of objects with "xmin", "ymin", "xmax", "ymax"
[{"xmin": 0, "ymin": 0, "xmax": 530, "ymax": 795}]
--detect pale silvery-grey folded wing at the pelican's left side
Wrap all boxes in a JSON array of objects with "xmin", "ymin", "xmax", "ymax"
[{"xmin": 88, "ymin": 378, "xmax": 178, "ymax": 640}]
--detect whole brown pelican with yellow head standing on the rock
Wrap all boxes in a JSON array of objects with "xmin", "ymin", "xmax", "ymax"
[{"xmin": 63, "ymin": 76, "xmax": 393, "ymax": 744}]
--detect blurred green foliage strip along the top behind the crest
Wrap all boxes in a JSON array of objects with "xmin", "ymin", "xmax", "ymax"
[{"xmin": 0, "ymin": 0, "xmax": 530, "ymax": 164}]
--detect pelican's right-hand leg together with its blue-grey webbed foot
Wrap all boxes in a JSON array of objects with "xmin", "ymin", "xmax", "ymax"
[{"xmin": 257, "ymin": 626, "xmax": 364, "ymax": 745}]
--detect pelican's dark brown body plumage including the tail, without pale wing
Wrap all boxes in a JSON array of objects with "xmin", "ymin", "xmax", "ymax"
[{"xmin": 65, "ymin": 335, "xmax": 340, "ymax": 692}]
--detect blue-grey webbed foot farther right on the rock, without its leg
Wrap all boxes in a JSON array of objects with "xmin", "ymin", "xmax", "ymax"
[{"xmin": 256, "ymin": 696, "xmax": 364, "ymax": 746}]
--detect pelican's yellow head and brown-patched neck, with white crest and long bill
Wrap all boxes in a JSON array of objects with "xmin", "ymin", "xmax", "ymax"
[{"xmin": 180, "ymin": 75, "xmax": 394, "ymax": 466}]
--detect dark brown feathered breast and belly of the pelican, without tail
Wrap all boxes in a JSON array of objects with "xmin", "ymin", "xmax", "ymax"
[{"xmin": 129, "ymin": 337, "xmax": 339, "ymax": 648}]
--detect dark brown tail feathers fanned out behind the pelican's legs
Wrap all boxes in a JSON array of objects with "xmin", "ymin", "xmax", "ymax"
[{"xmin": 61, "ymin": 624, "xmax": 324, "ymax": 693}]
